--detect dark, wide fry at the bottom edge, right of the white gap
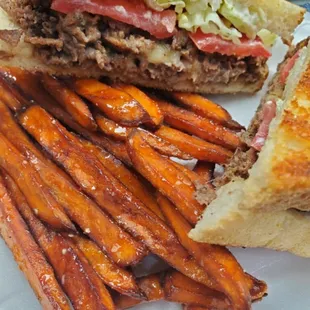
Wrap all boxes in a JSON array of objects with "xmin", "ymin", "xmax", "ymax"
[{"xmin": 164, "ymin": 271, "xmax": 230, "ymax": 310}]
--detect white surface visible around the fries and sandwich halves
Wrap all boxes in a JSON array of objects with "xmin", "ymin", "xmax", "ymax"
[{"xmin": 0, "ymin": 14, "xmax": 310, "ymax": 310}]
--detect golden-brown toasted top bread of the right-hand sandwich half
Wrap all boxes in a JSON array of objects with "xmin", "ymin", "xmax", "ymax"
[{"xmin": 244, "ymin": 43, "xmax": 310, "ymax": 211}]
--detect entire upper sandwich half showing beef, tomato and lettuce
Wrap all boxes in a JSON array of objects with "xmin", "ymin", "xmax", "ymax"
[{"xmin": 0, "ymin": 0, "xmax": 304, "ymax": 93}]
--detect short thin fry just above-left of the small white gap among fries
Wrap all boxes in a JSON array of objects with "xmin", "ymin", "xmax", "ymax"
[{"xmin": 139, "ymin": 128, "xmax": 193, "ymax": 160}]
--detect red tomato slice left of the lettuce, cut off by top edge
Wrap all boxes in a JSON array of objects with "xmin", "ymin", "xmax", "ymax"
[{"xmin": 52, "ymin": 0, "xmax": 177, "ymax": 39}]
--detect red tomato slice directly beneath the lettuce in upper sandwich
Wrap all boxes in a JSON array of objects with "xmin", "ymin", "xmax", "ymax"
[{"xmin": 190, "ymin": 30, "xmax": 271, "ymax": 58}]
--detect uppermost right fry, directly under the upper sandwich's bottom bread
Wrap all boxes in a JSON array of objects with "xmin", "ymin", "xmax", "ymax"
[{"xmin": 172, "ymin": 92, "xmax": 244, "ymax": 131}]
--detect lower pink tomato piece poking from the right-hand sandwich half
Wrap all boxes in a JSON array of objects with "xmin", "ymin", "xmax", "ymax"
[{"xmin": 251, "ymin": 100, "xmax": 277, "ymax": 151}]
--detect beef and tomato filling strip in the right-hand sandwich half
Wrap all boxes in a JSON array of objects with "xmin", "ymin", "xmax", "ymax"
[{"xmin": 215, "ymin": 38, "xmax": 310, "ymax": 187}]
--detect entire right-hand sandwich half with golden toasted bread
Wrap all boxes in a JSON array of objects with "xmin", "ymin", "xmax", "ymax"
[{"xmin": 190, "ymin": 39, "xmax": 310, "ymax": 257}]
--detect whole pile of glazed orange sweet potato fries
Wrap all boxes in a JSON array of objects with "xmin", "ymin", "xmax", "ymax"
[{"xmin": 0, "ymin": 68, "xmax": 267, "ymax": 310}]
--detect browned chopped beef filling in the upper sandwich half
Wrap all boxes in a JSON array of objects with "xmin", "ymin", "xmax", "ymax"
[{"xmin": 7, "ymin": 0, "xmax": 268, "ymax": 91}]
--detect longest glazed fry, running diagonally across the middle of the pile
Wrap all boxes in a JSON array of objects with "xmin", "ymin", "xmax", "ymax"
[{"xmin": 20, "ymin": 106, "xmax": 218, "ymax": 286}]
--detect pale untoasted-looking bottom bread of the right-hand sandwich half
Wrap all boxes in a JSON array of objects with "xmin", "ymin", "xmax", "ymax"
[{"xmin": 190, "ymin": 179, "xmax": 310, "ymax": 257}]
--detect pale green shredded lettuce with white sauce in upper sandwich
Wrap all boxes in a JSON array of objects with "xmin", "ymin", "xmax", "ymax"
[{"xmin": 152, "ymin": 0, "xmax": 276, "ymax": 46}]
